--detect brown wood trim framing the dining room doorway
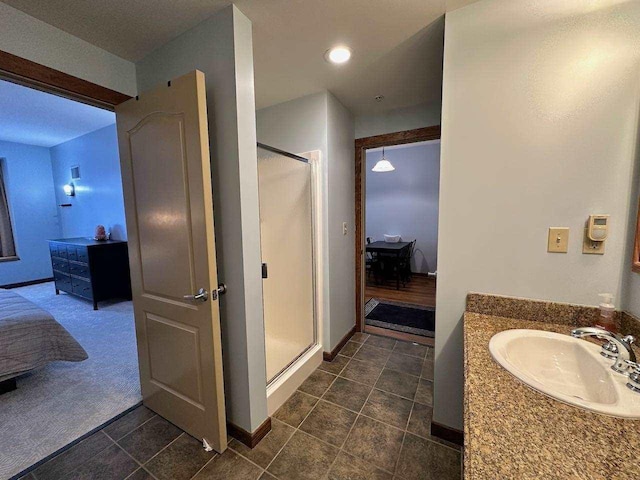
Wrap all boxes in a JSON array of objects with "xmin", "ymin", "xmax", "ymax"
[{"xmin": 355, "ymin": 125, "xmax": 441, "ymax": 332}]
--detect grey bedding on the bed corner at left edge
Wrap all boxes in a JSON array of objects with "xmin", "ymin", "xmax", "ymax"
[{"xmin": 0, "ymin": 289, "xmax": 88, "ymax": 381}]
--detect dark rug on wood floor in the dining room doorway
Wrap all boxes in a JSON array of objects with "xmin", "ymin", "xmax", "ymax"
[{"xmin": 364, "ymin": 298, "xmax": 436, "ymax": 338}]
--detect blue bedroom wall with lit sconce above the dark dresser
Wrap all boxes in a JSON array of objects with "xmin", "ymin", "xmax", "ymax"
[{"xmin": 51, "ymin": 124, "xmax": 127, "ymax": 240}]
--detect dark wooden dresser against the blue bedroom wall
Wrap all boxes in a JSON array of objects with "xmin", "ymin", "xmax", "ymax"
[{"xmin": 49, "ymin": 238, "xmax": 131, "ymax": 310}]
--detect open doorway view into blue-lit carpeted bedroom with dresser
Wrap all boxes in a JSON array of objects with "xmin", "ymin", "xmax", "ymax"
[{"xmin": 0, "ymin": 76, "xmax": 142, "ymax": 478}]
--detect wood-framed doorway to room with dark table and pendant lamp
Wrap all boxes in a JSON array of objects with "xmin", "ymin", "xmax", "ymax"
[{"xmin": 356, "ymin": 127, "xmax": 440, "ymax": 345}]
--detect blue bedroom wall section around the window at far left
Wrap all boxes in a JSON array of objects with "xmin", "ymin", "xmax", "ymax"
[{"xmin": 0, "ymin": 142, "xmax": 61, "ymax": 285}]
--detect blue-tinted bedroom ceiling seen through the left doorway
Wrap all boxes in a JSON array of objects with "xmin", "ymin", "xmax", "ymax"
[{"xmin": 0, "ymin": 80, "xmax": 116, "ymax": 147}]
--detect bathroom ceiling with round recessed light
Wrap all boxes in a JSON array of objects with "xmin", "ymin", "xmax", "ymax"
[{"xmin": 4, "ymin": 0, "xmax": 477, "ymax": 115}]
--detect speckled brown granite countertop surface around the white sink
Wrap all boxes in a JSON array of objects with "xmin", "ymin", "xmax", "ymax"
[{"xmin": 464, "ymin": 312, "xmax": 640, "ymax": 480}]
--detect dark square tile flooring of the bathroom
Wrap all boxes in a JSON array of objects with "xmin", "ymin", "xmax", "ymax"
[{"xmin": 23, "ymin": 334, "xmax": 462, "ymax": 480}]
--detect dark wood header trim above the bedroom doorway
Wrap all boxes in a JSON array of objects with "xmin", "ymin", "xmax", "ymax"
[{"xmin": 0, "ymin": 50, "xmax": 131, "ymax": 110}]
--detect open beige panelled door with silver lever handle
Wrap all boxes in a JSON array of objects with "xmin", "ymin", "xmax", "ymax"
[{"xmin": 116, "ymin": 71, "xmax": 226, "ymax": 451}]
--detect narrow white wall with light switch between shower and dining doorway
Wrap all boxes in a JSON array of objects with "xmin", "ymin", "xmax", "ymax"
[{"xmin": 327, "ymin": 93, "xmax": 356, "ymax": 350}]
